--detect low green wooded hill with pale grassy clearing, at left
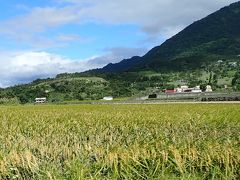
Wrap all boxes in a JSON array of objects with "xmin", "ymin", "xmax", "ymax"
[{"xmin": 0, "ymin": 73, "xmax": 140, "ymax": 104}]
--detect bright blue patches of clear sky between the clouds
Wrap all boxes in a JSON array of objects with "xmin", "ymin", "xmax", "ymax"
[{"xmin": 0, "ymin": 0, "xmax": 152, "ymax": 60}]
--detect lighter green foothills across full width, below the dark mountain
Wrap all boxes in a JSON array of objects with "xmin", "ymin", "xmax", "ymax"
[{"xmin": 0, "ymin": 58, "xmax": 240, "ymax": 104}]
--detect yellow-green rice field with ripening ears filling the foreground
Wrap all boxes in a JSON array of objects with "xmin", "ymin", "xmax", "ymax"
[{"xmin": 0, "ymin": 104, "xmax": 240, "ymax": 179}]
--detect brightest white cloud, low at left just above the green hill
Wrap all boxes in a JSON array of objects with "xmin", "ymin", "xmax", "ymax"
[{"xmin": 0, "ymin": 52, "xmax": 85, "ymax": 87}]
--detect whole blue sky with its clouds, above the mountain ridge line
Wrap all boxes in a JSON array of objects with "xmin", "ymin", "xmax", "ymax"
[{"xmin": 0, "ymin": 0, "xmax": 236, "ymax": 87}]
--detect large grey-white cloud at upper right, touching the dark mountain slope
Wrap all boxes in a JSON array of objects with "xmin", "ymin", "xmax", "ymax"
[{"xmin": 55, "ymin": 0, "xmax": 237, "ymax": 38}]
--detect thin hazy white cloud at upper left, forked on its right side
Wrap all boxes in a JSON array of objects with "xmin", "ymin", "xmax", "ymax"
[{"xmin": 0, "ymin": 6, "xmax": 83, "ymax": 49}]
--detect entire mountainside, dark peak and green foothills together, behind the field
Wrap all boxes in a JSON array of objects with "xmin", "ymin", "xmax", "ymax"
[{"xmin": 0, "ymin": 2, "xmax": 240, "ymax": 104}]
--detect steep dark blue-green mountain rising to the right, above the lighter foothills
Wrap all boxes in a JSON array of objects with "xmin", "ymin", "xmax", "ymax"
[{"xmin": 97, "ymin": 2, "xmax": 240, "ymax": 72}]
